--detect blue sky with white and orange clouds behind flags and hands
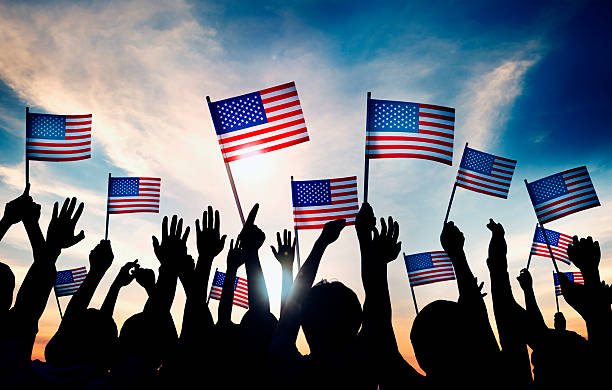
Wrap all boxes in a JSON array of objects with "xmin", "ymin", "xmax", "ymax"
[{"xmin": 0, "ymin": 0, "xmax": 612, "ymax": 367}]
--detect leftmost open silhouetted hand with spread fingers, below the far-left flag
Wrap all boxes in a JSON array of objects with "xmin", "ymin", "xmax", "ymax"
[{"xmin": 47, "ymin": 198, "xmax": 85, "ymax": 251}]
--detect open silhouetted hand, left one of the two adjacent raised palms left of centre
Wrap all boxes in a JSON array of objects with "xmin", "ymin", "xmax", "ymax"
[{"xmin": 153, "ymin": 215, "xmax": 189, "ymax": 271}]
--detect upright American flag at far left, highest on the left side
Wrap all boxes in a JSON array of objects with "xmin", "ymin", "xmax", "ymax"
[{"xmin": 26, "ymin": 114, "xmax": 91, "ymax": 161}]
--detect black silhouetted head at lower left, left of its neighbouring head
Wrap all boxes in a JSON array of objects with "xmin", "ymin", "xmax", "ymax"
[{"xmin": 45, "ymin": 309, "xmax": 117, "ymax": 371}]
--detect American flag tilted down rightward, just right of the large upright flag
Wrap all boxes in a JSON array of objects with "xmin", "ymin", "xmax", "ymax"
[{"xmin": 457, "ymin": 146, "xmax": 516, "ymax": 199}]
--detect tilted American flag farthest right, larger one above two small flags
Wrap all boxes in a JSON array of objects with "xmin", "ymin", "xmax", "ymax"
[{"xmin": 527, "ymin": 166, "xmax": 600, "ymax": 223}]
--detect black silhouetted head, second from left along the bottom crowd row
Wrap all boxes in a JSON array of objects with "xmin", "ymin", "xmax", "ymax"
[{"xmin": 119, "ymin": 313, "xmax": 178, "ymax": 370}]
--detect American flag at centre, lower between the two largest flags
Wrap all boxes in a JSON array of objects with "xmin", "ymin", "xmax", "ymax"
[{"xmin": 291, "ymin": 176, "xmax": 359, "ymax": 229}]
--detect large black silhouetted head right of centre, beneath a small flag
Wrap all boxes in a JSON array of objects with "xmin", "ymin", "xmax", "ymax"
[{"xmin": 410, "ymin": 300, "xmax": 482, "ymax": 380}]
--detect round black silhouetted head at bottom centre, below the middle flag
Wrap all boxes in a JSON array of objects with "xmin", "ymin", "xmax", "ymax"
[{"xmin": 301, "ymin": 280, "xmax": 362, "ymax": 353}]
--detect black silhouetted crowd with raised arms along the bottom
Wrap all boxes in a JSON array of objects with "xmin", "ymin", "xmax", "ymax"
[{"xmin": 0, "ymin": 186, "xmax": 612, "ymax": 390}]
